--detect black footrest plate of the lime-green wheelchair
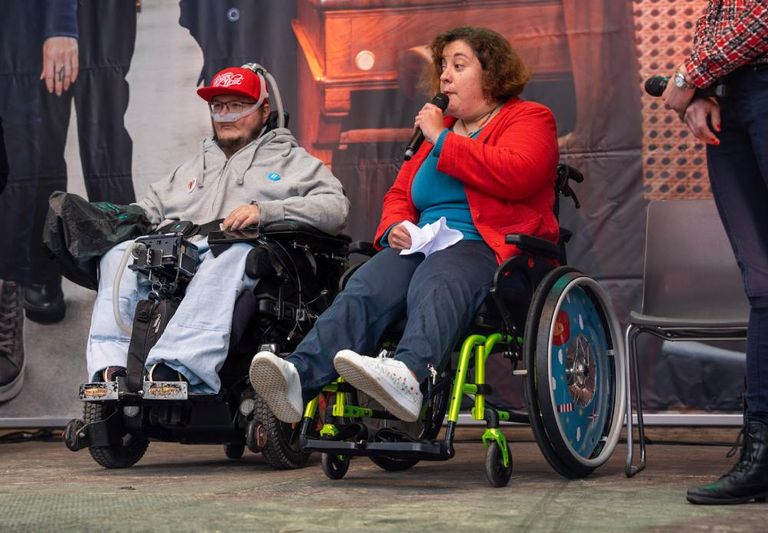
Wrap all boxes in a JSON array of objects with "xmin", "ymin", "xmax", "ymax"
[{"xmin": 303, "ymin": 439, "xmax": 453, "ymax": 461}]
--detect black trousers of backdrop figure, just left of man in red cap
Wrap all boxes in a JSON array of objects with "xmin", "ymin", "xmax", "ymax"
[{"xmin": 30, "ymin": 0, "xmax": 136, "ymax": 285}]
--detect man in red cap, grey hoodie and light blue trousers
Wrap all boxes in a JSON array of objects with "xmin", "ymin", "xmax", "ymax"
[{"xmin": 87, "ymin": 67, "xmax": 349, "ymax": 393}]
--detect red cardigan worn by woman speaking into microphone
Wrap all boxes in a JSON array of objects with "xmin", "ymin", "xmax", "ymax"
[{"xmin": 373, "ymin": 97, "xmax": 559, "ymax": 263}]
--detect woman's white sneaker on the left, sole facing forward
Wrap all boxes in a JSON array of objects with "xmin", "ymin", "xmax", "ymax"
[{"xmin": 248, "ymin": 352, "xmax": 304, "ymax": 424}]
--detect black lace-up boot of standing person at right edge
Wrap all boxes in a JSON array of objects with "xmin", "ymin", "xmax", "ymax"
[{"xmin": 687, "ymin": 420, "xmax": 768, "ymax": 505}]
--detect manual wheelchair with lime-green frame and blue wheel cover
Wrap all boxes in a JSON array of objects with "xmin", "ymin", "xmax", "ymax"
[{"xmin": 300, "ymin": 165, "xmax": 626, "ymax": 487}]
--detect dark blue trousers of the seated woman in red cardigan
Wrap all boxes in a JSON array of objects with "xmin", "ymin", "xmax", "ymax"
[{"xmin": 287, "ymin": 240, "xmax": 498, "ymax": 402}]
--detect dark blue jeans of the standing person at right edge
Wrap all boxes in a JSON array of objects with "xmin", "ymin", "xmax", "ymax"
[{"xmin": 707, "ymin": 66, "xmax": 768, "ymax": 423}]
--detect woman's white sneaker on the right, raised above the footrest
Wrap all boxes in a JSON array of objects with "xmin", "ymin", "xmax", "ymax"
[{"xmin": 333, "ymin": 350, "xmax": 424, "ymax": 422}]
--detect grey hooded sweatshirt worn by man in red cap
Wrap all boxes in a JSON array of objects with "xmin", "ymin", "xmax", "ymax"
[{"xmin": 136, "ymin": 128, "xmax": 349, "ymax": 235}]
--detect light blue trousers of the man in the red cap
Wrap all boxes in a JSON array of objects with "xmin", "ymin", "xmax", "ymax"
[{"xmin": 87, "ymin": 240, "xmax": 256, "ymax": 394}]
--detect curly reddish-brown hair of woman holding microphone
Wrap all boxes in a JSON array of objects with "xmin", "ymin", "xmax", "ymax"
[{"xmin": 423, "ymin": 26, "xmax": 531, "ymax": 102}]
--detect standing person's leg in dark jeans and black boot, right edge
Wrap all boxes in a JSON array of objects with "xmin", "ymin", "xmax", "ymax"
[{"xmin": 688, "ymin": 67, "xmax": 768, "ymax": 503}]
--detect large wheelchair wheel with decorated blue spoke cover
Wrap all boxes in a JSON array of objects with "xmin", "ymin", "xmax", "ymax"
[{"xmin": 523, "ymin": 267, "xmax": 625, "ymax": 478}]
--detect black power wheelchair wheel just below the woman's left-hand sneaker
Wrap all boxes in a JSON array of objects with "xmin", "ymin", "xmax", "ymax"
[{"xmin": 254, "ymin": 395, "xmax": 310, "ymax": 470}]
